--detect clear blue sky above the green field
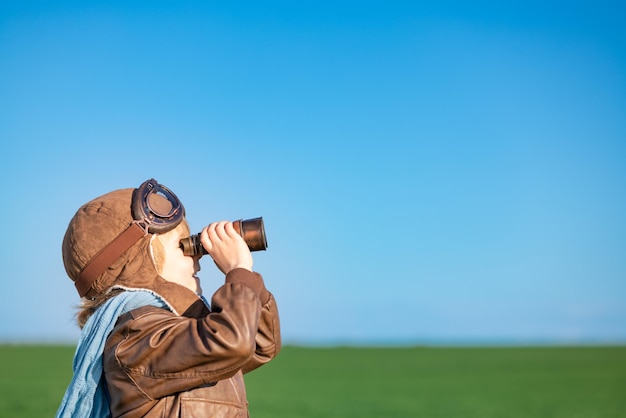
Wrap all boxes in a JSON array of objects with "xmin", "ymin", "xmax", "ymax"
[{"xmin": 0, "ymin": 1, "xmax": 626, "ymax": 344}]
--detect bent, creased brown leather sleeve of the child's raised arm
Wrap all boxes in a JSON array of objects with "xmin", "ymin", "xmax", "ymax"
[{"xmin": 105, "ymin": 269, "xmax": 280, "ymax": 399}]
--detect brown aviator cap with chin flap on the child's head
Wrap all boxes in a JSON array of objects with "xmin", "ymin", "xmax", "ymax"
[{"xmin": 62, "ymin": 182, "xmax": 208, "ymax": 313}]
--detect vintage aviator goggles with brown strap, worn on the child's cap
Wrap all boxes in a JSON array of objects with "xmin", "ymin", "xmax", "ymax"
[{"xmin": 74, "ymin": 179, "xmax": 185, "ymax": 297}]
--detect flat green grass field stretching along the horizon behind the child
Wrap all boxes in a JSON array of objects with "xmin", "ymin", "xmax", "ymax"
[{"xmin": 0, "ymin": 345, "xmax": 626, "ymax": 418}]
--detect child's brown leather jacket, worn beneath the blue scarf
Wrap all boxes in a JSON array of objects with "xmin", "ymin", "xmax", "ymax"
[{"xmin": 104, "ymin": 269, "xmax": 281, "ymax": 417}]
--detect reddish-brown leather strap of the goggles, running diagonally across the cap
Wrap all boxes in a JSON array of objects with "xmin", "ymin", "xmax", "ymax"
[{"xmin": 74, "ymin": 221, "xmax": 148, "ymax": 297}]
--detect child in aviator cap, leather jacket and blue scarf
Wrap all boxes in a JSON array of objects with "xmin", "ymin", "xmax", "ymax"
[{"xmin": 57, "ymin": 179, "xmax": 281, "ymax": 418}]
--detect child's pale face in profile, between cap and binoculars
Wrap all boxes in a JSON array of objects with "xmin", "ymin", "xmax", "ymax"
[{"xmin": 159, "ymin": 228, "xmax": 202, "ymax": 294}]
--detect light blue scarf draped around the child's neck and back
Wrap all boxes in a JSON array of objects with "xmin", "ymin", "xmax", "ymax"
[{"xmin": 56, "ymin": 290, "xmax": 168, "ymax": 418}]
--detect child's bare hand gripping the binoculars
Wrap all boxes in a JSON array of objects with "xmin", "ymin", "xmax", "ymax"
[{"xmin": 200, "ymin": 221, "xmax": 252, "ymax": 274}]
